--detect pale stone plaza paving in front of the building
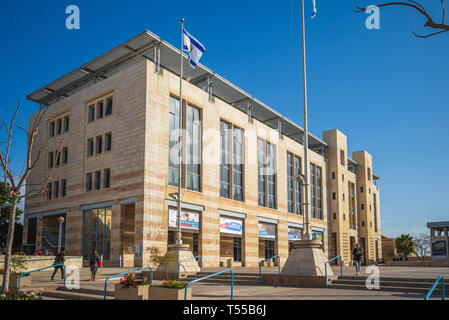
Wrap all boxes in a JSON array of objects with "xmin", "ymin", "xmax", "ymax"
[{"xmin": 9, "ymin": 266, "xmax": 449, "ymax": 300}]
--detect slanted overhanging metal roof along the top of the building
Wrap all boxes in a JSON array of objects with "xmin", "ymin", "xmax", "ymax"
[{"xmin": 27, "ymin": 30, "xmax": 327, "ymax": 150}]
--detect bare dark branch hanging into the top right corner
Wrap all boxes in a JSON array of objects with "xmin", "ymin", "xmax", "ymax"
[{"xmin": 354, "ymin": 0, "xmax": 449, "ymax": 38}]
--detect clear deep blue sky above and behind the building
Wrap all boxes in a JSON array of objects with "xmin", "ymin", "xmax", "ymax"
[{"xmin": 0, "ymin": 0, "xmax": 449, "ymax": 236}]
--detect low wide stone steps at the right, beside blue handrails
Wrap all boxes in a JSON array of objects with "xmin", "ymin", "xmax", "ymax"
[{"xmin": 328, "ymin": 276, "xmax": 449, "ymax": 297}]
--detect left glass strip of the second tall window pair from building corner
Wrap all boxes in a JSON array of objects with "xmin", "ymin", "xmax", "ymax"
[{"xmin": 220, "ymin": 121, "xmax": 231, "ymax": 199}]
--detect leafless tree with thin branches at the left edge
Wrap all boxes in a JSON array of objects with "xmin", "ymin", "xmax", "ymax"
[{"xmin": 0, "ymin": 101, "xmax": 64, "ymax": 293}]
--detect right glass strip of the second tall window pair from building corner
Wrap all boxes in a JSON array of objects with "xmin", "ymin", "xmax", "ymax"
[{"xmin": 232, "ymin": 127, "xmax": 244, "ymax": 201}]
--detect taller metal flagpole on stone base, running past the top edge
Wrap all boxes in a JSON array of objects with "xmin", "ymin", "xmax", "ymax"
[{"xmin": 301, "ymin": 0, "xmax": 312, "ymax": 240}]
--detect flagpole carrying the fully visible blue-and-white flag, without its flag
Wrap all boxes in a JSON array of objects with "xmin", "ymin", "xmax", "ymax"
[{"xmin": 176, "ymin": 18, "xmax": 184, "ymax": 245}]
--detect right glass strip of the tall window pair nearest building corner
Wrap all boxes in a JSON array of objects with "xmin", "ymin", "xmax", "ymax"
[{"xmin": 186, "ymin": 105, "xmax": 201, "ymax": 191}]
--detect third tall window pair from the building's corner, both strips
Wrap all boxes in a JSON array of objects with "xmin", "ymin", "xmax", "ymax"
[{"xmin": 257, "ymin": 138, "xmax": 277, "ymax": 209}]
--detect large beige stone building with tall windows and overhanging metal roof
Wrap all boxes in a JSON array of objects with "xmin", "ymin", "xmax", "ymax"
[{"xmin": 23, "ymin": 31, "xmax": 381, "ymax": 267}]
